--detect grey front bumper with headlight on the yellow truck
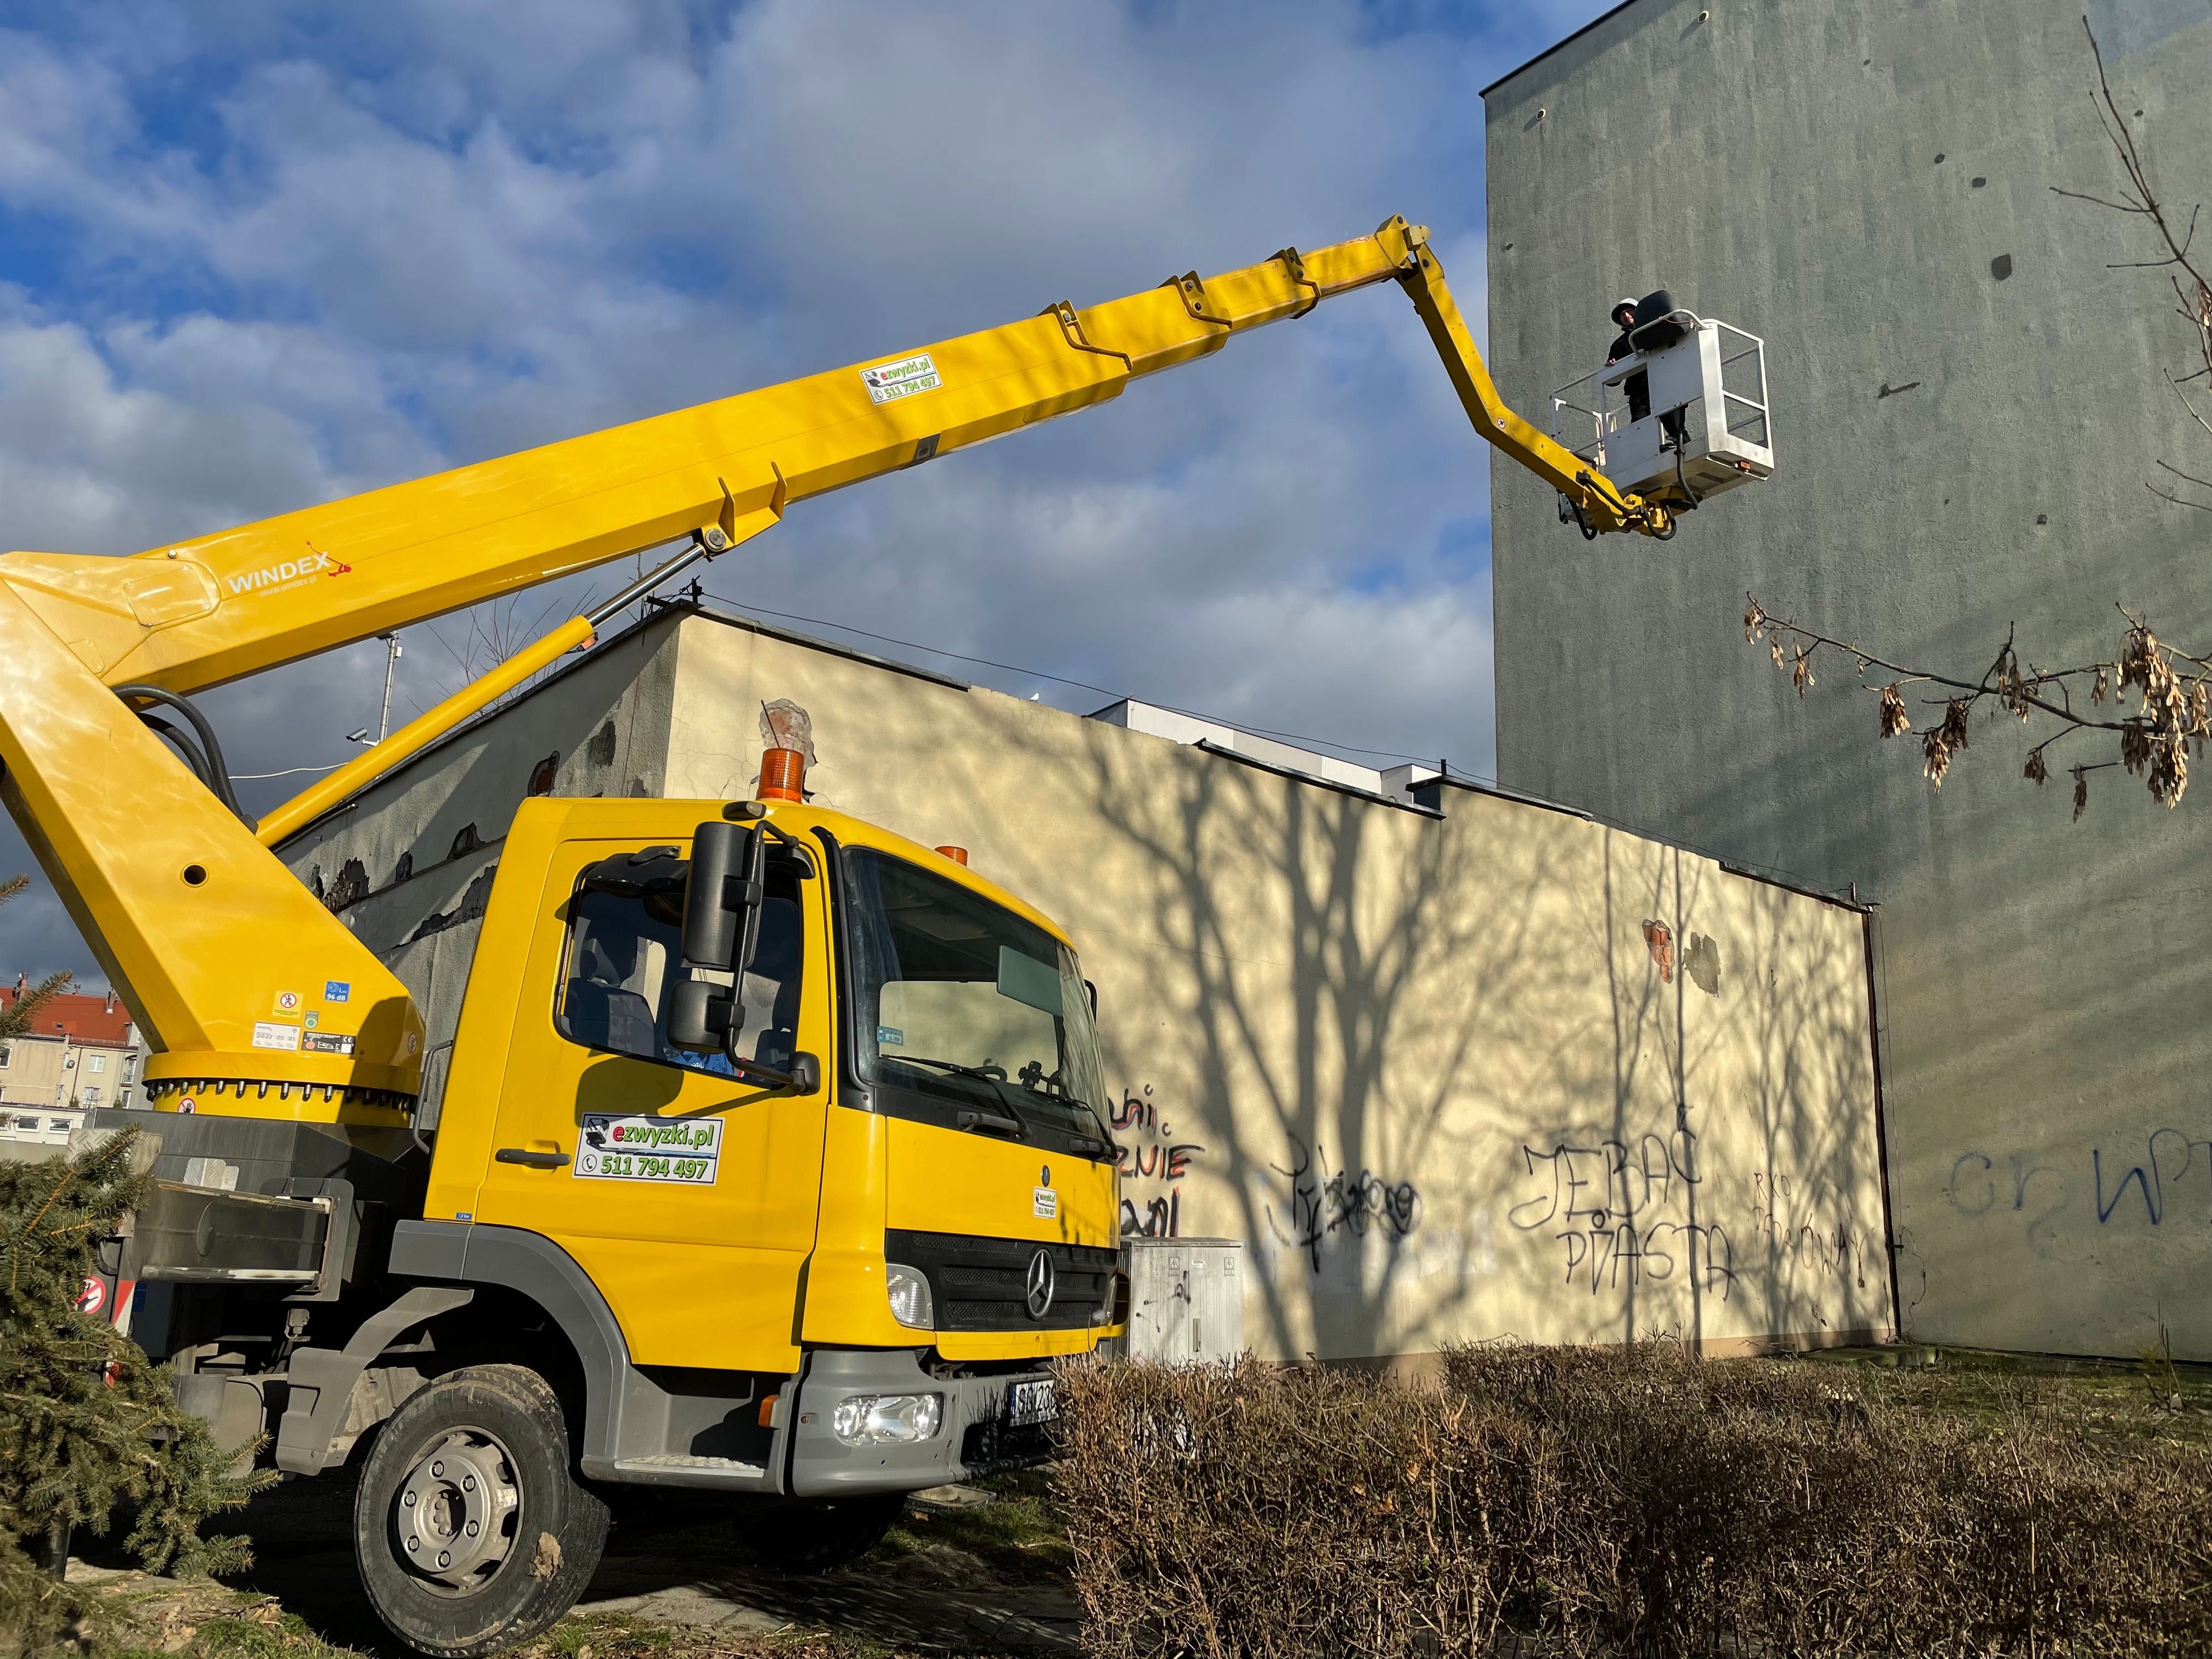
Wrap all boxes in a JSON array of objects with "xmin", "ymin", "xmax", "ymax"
[{"xmin": 785, "ymin": 1347, "xmax": 1051, "ymax": 1498}]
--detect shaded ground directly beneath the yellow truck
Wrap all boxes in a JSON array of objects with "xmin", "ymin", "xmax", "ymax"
[{"xmin": 212, "ymin": 1477, "xmax": 1077, "ymax": 1659}]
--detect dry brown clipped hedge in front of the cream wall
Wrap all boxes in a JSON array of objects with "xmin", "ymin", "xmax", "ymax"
[{"xmin": 1062, "ymin": 1345, "xmax": 2212, "ymax": 1659}]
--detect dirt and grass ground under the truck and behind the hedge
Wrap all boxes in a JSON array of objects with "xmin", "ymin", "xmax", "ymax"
[{"xmin": 71, "ymin": 1345, "xmax": 2212, "ymax": 1659}]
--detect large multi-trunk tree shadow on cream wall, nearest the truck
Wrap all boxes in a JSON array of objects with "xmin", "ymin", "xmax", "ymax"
[{"xmin": 995, "ymin": 732, "xmax": 1560, "ymax": 1358}]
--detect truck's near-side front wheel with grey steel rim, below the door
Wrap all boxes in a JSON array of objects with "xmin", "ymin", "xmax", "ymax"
[{"xmin": 354, "ymin": 1365, "xmax": 606, "ymax": 1659}]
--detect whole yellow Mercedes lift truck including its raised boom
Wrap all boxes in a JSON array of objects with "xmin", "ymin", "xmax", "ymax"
[{"xmin": 0, "ymin": 219, "xmax": 1672, "ymax": 1655}]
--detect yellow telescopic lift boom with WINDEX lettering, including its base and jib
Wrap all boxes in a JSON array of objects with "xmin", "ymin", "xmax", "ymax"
[{"xmin": 0, "ymin": 208, "xmax": 1668, "ymax": 1121}]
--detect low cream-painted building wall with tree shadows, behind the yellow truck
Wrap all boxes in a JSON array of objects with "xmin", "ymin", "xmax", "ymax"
[{"xmin": 285, "ymin": 615, "xmax": 1891, "ymax": 1358}]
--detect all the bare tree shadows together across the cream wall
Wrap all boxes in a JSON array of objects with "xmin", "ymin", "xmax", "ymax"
[{"xmin": 1007, "ymin": 723, "xmax": 1887, "ymax": 1358}]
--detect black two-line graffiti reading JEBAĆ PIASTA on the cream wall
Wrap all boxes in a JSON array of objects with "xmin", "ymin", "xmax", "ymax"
[{"xmin": 1506, "ymin": 1128, "xmax": 1736, "ymax": 1301}]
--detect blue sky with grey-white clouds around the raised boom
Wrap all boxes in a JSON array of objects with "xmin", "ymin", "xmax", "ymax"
[{"xmin": 0, "ymin": 0, "xmax": 1606, "ymax": 980}]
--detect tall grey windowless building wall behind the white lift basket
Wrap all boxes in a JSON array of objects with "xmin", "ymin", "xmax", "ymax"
[{"xmin": 1487, "ymin": 0, "xmax": 2212, "ymax": 1358}]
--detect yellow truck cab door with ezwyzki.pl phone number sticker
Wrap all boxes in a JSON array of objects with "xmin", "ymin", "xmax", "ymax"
[{"xmin": 476, "ymin": 840, "xmax": 834, "ymax": 1372}]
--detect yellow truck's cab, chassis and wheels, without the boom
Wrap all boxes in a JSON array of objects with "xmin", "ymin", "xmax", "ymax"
[{"xmin": 106, "ymin": 789, "xmax": 1126, "ymax": 1655}]
